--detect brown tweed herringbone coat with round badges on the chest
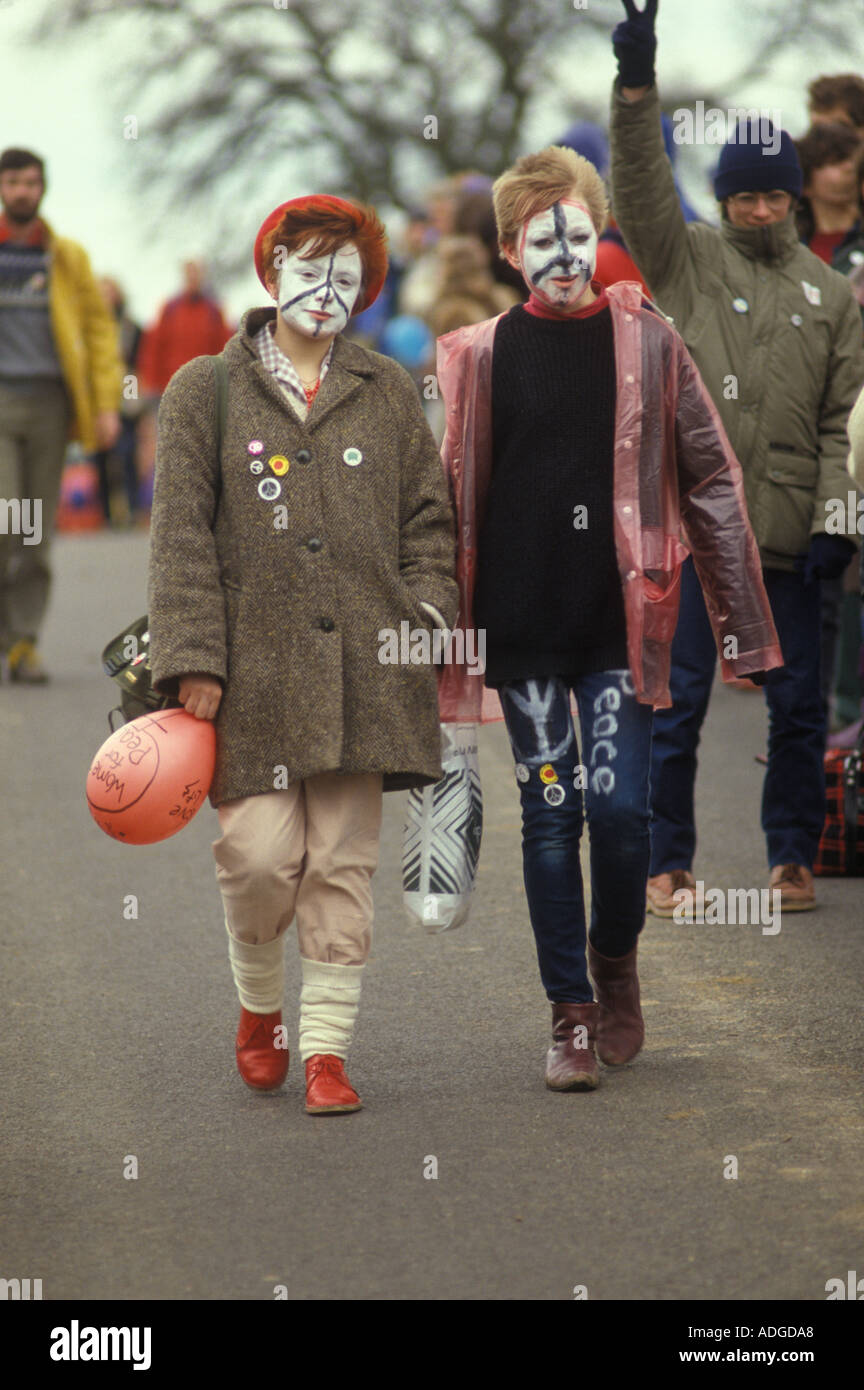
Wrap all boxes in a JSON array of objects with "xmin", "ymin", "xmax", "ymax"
[{"xmin": 149, "ymin": 309, "xmax": 457, "ymax": 806}]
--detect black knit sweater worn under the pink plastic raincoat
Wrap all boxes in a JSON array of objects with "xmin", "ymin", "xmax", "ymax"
[{"xmin": 474, "ymin": 304, "xmax": 626, "ymax": 687}]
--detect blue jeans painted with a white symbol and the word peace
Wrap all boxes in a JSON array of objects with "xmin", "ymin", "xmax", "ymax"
[{"xmin": 499, "ymin": 671, "xmax": 651, "ymax": 1004}]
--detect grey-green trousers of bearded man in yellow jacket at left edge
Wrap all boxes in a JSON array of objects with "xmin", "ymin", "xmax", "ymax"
[{"xmin": 0, "ymin": 378, "xmax": 71, "ymax": 651}]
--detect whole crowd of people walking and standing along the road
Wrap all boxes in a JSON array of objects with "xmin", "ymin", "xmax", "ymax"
[{"xmin": 0, "ymin": 0, "xmax": 864, "ymax": 1113}]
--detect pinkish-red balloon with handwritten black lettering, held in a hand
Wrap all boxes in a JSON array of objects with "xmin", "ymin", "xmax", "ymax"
[{"xmin": 86, "ymin": 709, "xmax": 215, "ymax": 845}]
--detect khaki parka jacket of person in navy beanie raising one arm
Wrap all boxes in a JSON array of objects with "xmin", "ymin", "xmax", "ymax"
[{"xmin": 610, "ymin": 83, "xmax": 864, "ymax": 570}]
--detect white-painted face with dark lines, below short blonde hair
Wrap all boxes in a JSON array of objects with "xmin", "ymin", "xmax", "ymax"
[{"xmin": 517, "ymin": 197, "xmax": 597, "ymax": 313}]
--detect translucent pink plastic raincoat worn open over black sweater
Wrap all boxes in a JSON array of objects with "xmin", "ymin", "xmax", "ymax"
[{"xmin": 438, "ymin": 281, "xmax": 783, "ymax": 723}]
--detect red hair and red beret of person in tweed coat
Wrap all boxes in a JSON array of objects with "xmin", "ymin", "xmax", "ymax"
[{"xmin": 256, "ymin": 193, "xmax": 388, "ymax": 314}]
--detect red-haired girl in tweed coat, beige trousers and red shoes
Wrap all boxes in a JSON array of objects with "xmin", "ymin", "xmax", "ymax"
[{"xmin": 150, "ymin": 196, "xmax": 457, "ymax": 1113}]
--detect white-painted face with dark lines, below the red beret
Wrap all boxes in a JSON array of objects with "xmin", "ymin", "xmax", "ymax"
[{"xmin": 278, "ymin": 238, "xmax": 363, "ymax": 338}]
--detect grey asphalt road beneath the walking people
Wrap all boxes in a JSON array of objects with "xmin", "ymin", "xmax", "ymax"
[{"xmin": 0, "ymin": 534, "xmax": 864, "ymax": 1300}]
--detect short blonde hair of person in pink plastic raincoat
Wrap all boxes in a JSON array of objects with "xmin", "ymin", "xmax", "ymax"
[{"xmin": 492, "ymin": 145, "xmax": 608, "ymax": 247}]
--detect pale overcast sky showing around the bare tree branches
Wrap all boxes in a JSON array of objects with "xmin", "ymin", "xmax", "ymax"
[{"xmin": 0, "ymin": 0, "xmax": 864, "ymax": 321}]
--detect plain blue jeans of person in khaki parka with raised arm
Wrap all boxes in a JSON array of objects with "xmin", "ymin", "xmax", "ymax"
[{"xmin": 651, "ymin": 559, "xmax": 825, "ymax": 876}]
